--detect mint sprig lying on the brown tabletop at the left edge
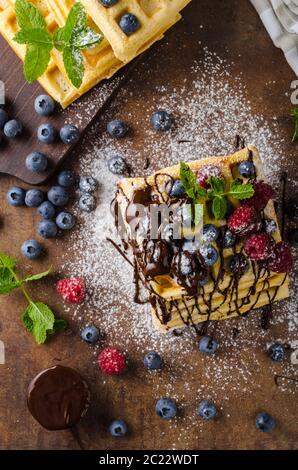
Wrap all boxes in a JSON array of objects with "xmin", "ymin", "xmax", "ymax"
[{"xmin": 0, "ymin": 252, "xmax": 67, "ymax": 344}]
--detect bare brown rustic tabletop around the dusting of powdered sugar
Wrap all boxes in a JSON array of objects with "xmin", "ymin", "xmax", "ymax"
[{"xmin": 0, "ymin": 0, "xmax": 298, "ymax": 449}]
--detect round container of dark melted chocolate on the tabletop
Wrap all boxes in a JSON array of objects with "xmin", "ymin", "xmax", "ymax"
[{"xmin": 27, "ymin": 366, "xmax": 90, "ymax": 431}]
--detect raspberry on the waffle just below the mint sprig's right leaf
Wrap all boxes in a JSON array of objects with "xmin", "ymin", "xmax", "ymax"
[{"xmin": 228, "ymin": 206, "xmax": 262, "ymax": 236}]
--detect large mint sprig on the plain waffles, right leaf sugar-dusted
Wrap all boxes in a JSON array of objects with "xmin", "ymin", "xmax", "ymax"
[{"xmin": 14, "ymin": 0, "xmax": 103, "ymax": 88}]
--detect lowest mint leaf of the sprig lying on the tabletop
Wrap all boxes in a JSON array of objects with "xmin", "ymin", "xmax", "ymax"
[{"xmin": 22, "ymin": 302, "xmax": 55, "ymax": 344}]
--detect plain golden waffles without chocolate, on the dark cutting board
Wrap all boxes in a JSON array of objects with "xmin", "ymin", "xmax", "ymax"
[{"xmin": 0, "ymin": 0, "xmax": 190, "ymax": 108}]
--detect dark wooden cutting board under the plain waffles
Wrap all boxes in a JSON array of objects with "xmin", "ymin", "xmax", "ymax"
[{"xmin": 0, "ymin": 36, "xmax": 137, "ymax": 184}]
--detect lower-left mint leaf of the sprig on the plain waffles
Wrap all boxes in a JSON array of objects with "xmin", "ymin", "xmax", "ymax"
[{"xmin": 24, "ymin": 45, "xmax": 51, "ymax": 83}]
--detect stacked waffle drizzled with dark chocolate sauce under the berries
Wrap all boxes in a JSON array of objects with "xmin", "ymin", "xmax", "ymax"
[{"xmin": 116, "ymin": 146, "xmax": 291, "ymax": 331}]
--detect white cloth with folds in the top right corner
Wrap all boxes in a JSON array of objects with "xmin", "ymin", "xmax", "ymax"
[{"xmin": 250, "ymin": 0, "xmax": 298, "ymax": 76}]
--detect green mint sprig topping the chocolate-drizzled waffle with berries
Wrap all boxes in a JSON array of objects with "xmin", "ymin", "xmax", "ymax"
[{"xmin": 180, "ymin": 162, "xmax": 254, "ymax": 220}]
